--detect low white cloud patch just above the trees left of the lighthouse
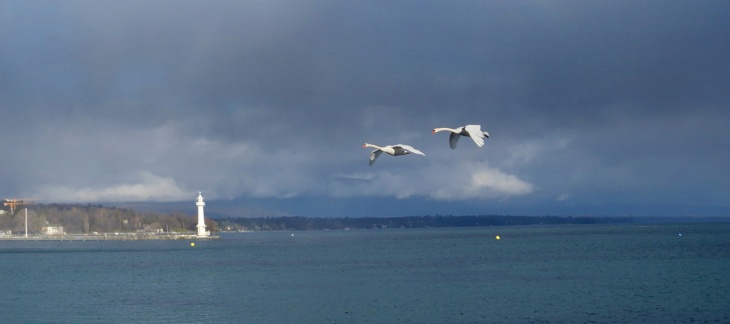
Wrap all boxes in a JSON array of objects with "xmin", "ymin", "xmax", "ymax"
[{"xmin": 36, "ymin": 172, "xmax": 191, "ymax": 202}]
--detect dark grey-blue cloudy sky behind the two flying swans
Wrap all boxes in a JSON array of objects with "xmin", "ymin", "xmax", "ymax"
[{"xmin": 0, "ymin": 0, "xmax": 730, "ymax": 216}]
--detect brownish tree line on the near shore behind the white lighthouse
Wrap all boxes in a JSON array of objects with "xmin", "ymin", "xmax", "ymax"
[{"xmin": 0, "ymin": 204, "xmax": 218, "ymax": 234}]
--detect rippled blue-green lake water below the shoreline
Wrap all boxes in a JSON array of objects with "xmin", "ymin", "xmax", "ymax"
[{"xmin": 0, "ymin": 224, "xmax": 730, "ymax": 323}]
